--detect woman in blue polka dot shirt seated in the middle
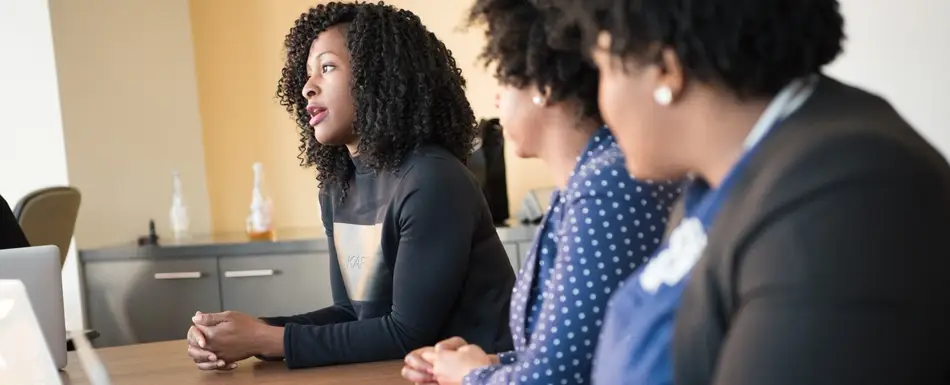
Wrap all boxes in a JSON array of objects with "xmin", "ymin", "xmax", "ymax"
[{"xmin": 403, "ymin": 0, "xmax": 679, "ymax": 385}]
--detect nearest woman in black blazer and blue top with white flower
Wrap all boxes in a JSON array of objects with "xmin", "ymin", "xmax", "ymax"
[{"xmin": 557, "ymin": 0, "xmax": 950, "ymax": 385}]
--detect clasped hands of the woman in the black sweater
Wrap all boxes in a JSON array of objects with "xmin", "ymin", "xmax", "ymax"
[{"xmin": 187, "ymin": 311, "xmax": 284, "ymax": 370}]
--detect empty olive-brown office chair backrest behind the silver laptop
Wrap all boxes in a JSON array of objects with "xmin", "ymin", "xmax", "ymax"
[{"xmin": 13, "ymin": 186, "xmax": 82, "ymax": 266}]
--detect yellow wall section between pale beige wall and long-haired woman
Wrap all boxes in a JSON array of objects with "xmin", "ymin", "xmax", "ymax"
[{"xmin": 190, "ymin": 0, "xmax": 320, "ymax": 232}]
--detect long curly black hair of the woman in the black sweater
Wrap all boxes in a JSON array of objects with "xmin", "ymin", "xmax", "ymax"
[{"xmin": 277, "ymin": 2, "xmax": 476, "ymax": 196}]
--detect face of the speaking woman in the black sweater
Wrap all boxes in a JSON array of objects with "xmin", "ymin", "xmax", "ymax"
[{"xmin": 301, "ymin": 25, "xmax": 357, "ymax": 145}]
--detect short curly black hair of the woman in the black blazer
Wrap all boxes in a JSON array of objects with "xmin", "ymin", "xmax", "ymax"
[{"xmin": 554, "ymin": 0, "xmax": 845, "ymax": 98}]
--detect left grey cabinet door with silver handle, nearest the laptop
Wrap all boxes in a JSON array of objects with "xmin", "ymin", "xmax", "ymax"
[{"xmin": 83, "ymin": 257, "xmax": 221, "ymax": 347}]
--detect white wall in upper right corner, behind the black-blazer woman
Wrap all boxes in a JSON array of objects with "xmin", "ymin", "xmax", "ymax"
[{"xmin": 827, "ymin": 0, "xmax": 950, "ymax": 157}]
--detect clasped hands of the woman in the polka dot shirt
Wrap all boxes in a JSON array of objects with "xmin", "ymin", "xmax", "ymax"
[{"xmin": 402, "ymin": 337, "xmax": 499, "ymax": 385}]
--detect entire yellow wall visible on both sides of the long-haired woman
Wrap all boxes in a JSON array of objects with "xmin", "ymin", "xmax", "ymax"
[{"xmin": 191, "ymin": 0, "xmax": 550, "ymax": 231}]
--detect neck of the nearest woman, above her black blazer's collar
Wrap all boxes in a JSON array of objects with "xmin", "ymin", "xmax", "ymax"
[{"xmin": 690, "ymin": 94, "xmax": 769, "ymax": 188}]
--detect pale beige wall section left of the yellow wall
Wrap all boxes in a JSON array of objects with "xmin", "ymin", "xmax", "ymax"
[{"xmin": 49, "ymin": 0, "xmax": 210, "ymax": 248}]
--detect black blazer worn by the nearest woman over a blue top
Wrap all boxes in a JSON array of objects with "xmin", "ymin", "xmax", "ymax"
[{"xmin": 673, "ymin": 77, "xmax": 950, "ymax": 385}]
